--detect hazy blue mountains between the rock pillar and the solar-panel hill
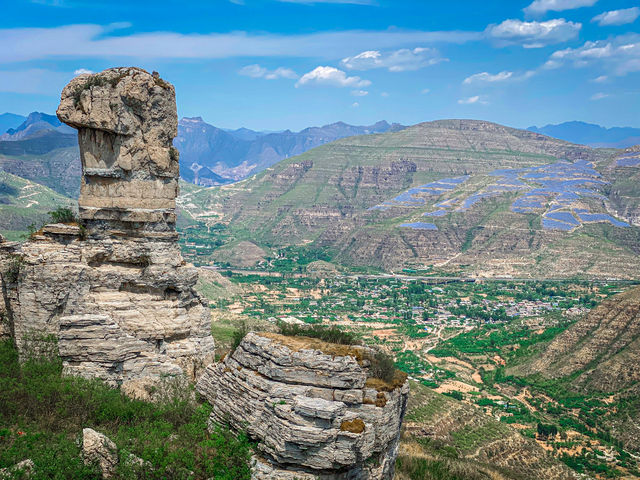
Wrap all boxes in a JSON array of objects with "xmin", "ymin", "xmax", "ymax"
[{"xmin": 174, "ymin": 117, "xmax": 406, "ymax": 186}]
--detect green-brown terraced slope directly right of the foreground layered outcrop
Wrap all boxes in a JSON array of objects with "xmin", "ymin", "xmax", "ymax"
[{"xmin": 397, "ymin": 383, "xmax": 578, "ymax": 480}]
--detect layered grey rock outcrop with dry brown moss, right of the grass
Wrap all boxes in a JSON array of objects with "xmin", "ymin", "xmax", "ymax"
[{"xmin": 197, "ymin": 333, "xmax": 409, "ymax": 480}]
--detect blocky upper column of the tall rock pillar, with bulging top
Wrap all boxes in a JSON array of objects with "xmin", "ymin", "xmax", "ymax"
[{"xmin": 58, "ymin": 68, "xmax": 178, "ymax": 235}]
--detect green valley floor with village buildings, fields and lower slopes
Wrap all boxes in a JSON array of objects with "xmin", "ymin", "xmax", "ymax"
[{"xmin": 199, "ymin": 264, "xmax": 640, "ymax": 479}]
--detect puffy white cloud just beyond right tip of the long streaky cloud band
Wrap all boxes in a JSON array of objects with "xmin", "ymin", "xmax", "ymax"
[{"xmin": 486, "ymin": 18, "xmax": 582, "ymax": 48}]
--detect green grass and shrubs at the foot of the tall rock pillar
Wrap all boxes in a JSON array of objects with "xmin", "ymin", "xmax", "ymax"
[{"xmin": 0, "ymin": 341, "xmax": 252, "ymax": 480}]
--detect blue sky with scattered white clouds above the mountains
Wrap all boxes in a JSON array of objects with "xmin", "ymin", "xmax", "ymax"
[{"xmin": 0, "ymin": 0, "xmax": 640, "ymax": 130}]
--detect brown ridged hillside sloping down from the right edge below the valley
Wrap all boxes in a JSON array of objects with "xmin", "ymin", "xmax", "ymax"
[{"xmin": 507, "ymin": 287, "xmax": 640, "ymax": 451}]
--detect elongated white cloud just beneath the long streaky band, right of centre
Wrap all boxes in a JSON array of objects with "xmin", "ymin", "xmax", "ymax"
[{"xmin": 341, "ymin": 48, "xmax": 446, "ymax": 72}]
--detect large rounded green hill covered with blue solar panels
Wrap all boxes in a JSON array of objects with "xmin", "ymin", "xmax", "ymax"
[{"xmin": 183, "ymin": 120, "xmax": 640, "ymax": 278}]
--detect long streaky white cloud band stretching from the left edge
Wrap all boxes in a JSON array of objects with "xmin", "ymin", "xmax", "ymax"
[{"xmin": 0, "ymin": 24, "xmax": 482, "ymax": 63}]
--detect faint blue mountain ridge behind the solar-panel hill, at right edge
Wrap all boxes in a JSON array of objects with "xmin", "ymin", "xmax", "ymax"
[{"xmin": 527, "ymin": 122, "xmax": 640, "ymax": 148}]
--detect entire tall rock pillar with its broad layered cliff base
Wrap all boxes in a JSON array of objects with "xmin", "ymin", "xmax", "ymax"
[{"xmin": 0, "ymin": 68, "xmax": 214, "ymax": 384}]
